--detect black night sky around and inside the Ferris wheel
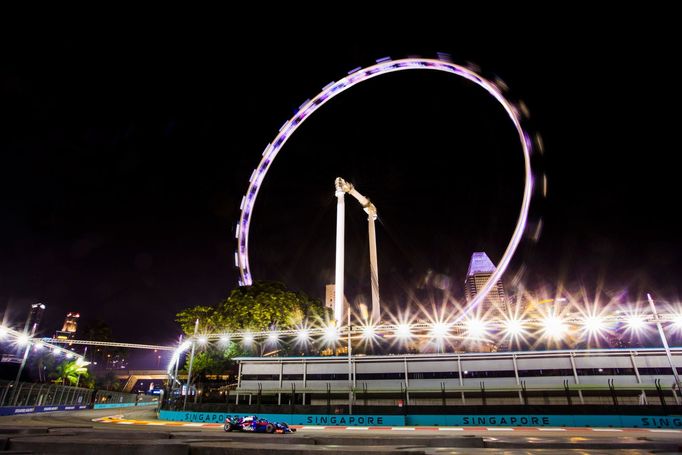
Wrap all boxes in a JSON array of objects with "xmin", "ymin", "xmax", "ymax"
[{"xmin": 0, "ymin": 17, "xmax": 682, "ymax": 344}]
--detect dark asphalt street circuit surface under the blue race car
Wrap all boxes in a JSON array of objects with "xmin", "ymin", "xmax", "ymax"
[{"xmin": 0, "ymin": 409, "xmax": 682, "ymax": 455}]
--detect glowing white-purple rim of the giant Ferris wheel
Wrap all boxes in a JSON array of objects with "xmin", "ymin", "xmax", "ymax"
[{"xmin": 235, "ymin": 57, "xmax": 533, "ymax": 313}]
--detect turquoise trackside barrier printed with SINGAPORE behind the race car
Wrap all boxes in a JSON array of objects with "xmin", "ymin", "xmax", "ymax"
[{"xmin": 159, "ymin": 410, "xmax": 682, "ymax": 428}]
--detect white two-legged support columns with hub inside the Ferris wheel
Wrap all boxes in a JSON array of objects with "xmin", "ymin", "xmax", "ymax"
[{"xmin": 334, "ymin": 177, "xmax": 381, "ymax": 326}]
